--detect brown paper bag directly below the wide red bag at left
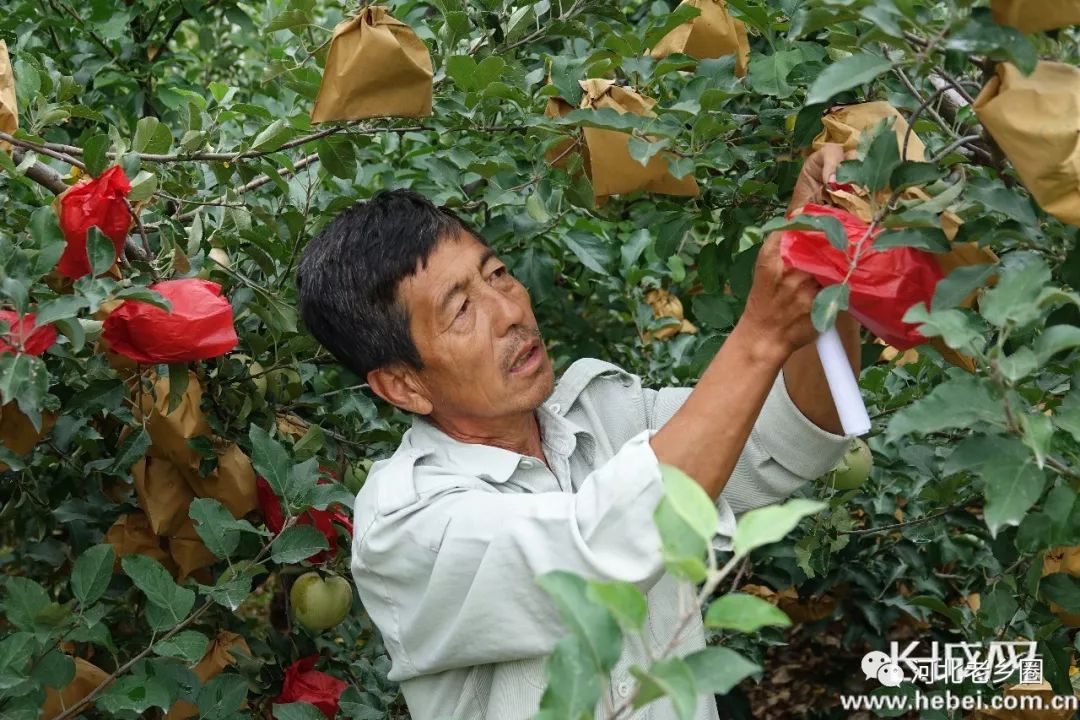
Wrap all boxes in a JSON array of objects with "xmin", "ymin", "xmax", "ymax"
[{"xmin": 132, "ymin": 370, "xmax": 210, "ymax": 470}]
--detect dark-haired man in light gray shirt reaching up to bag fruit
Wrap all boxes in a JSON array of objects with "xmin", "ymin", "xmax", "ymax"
[{"xmin": 297, "ymin": 146, "xmax": 859, "ymax": 720}]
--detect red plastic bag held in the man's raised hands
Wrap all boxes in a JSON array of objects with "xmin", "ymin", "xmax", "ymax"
[{"xmin": 780, "ymin": 205, "xmax": 944, "ymax": 350}]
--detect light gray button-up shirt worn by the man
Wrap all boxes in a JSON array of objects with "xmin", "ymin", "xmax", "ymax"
[{"xmin": 352, "ymin": 358, "xmax": 848, "ymax": 720}]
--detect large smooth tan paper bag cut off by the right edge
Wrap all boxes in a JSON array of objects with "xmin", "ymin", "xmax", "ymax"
[{"xmin": 972, "ymin": 63, "xmax": 1080, "ymax": 226}]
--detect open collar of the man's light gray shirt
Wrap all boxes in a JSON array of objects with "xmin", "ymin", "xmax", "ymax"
[{"xmin": 403, "ymin": 405, "xmax": 595, "ymax": 484}]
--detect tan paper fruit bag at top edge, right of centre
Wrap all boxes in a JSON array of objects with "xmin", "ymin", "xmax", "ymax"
[{"xmin": 649, "ymin": 0, "xmax": 750, "ymax": 78}]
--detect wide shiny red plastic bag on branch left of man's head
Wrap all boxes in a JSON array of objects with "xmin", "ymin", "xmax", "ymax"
[{"xmin": 102, "ymin": 277, "xmax": 239, "ymax": 365}]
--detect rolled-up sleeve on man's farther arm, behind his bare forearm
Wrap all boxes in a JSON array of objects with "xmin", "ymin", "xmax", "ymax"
[{"xmin": 643, "ymin": 369, "xmax": 849, "ymax": 515}]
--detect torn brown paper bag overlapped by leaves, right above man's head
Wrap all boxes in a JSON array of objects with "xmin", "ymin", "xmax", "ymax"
[{"xmin": 545, "ymin": 79, "xmax": 700, "ymax": 201}]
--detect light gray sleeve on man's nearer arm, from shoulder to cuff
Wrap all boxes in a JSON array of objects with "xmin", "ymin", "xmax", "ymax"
[{"xmin": 352, "ymin": 430, "xmax": 664, "ymax": 680}]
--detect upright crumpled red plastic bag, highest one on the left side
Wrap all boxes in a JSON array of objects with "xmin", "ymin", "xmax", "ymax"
[{"xmin": 56, "ymin": 165, "xmax": 132, "ymax": 277}]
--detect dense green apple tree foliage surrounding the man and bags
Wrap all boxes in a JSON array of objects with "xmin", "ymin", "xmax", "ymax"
[{"xmin": 0, "ymin": 0, "xmax": 1080, "ymax": 718}]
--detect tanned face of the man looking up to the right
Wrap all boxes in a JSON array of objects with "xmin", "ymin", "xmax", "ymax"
[{"xmin": 397, "ymin": 232, "xmax": 555, "ymax": 419}]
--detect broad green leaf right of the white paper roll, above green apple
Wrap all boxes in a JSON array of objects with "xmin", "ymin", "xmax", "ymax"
[{"xmin": 886, "ymin": 376, "xmax": 1004, "ymax": 443}]
